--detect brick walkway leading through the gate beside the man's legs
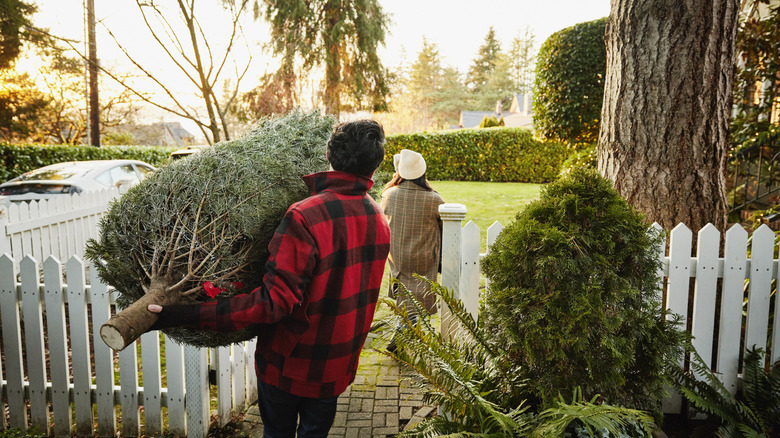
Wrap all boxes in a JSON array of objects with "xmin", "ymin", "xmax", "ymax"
[{"xmin": 239, "ymin": 333, "xmax": 435, "ymax": 438}]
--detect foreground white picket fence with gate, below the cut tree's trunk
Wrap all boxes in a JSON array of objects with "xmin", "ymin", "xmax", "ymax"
[{"xmin": 0, "ymin": 254, "xmax": 257, "ymax": 437}]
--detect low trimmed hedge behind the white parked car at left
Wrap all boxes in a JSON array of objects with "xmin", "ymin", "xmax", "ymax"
[{"xmin": 0, "ymin": 143, "xmax": 179, "ymax": 182}]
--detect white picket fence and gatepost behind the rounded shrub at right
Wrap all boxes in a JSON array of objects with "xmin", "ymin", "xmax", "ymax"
[{"xmin": 439, "ymin": 204, "xmax": 780, "ymax": 413}]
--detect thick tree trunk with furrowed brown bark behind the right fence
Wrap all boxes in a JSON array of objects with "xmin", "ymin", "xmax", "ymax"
[{"xmin": 598, "ymin": 0, "xmax": 739, "ymax": 231}]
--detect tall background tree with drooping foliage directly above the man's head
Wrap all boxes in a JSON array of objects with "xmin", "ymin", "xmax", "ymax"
[{"xmin": 265, "ymin": 0, "xmax": 389, "ymax": 116}]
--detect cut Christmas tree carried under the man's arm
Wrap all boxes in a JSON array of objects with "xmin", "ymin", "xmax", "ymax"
[{"xmin": 86, "ymin": 111, "xmax": 335, "ymax": 349}]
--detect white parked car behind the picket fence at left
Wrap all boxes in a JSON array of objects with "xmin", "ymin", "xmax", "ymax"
[{"xmin": 0, "ymin": 160, "xmax": 156, "ymax": 202}]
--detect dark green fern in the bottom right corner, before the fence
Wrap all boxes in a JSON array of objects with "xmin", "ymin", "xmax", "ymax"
[{"xmin": 671, "ymin": 347, "xmax": 780, "ymax": 438}]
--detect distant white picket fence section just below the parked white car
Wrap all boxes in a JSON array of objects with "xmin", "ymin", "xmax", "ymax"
[{"xmin": 0, "ymin": 188, "xmax": 119, "ymax": 263}]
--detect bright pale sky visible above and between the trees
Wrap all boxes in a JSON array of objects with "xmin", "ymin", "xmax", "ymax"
[{"xmin": 27, "ymin": 0, "xmax": 610, "ymax": 132}]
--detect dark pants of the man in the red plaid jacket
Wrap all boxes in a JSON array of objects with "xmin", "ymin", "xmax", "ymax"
[{"xmin": 257, "ymin": 381, "xmax": 339, "ymax": 438}]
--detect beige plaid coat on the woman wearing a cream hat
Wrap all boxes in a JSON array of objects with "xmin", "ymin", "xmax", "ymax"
[{"xmin": 382, "ymin": 181, "xmax": 444, "ymax": 313}]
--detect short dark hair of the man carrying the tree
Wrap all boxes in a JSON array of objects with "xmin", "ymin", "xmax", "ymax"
[{"xmin": 328, "ymin": 119, "xmax": 385, "ymax": 176}]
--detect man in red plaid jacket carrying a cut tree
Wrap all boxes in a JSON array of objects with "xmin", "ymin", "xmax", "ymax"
[{"xmin": 148, "ymin": 120, "xmax": 390, "ymax": 437}]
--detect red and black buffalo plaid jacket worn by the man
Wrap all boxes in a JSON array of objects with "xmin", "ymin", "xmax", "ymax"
[{"xmin": 190, "ymin": 171, "xmax": 390, "ymax": 398}]
